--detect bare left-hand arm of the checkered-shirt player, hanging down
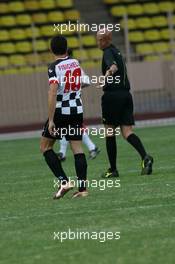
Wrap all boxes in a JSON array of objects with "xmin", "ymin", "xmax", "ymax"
[{"xmin": 48, "ymin": 83, "xmax": 58, "ymax": 134}]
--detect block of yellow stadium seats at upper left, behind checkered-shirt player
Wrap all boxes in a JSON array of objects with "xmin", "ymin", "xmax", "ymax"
[{"xmin": 0, "ymin": 0, "xmax": 101, "ymax": 74}]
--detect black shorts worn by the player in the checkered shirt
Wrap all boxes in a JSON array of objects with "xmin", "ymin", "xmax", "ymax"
[{"xmin": 42, "ymin": 110, "xmax": 83, "ymax": 141}]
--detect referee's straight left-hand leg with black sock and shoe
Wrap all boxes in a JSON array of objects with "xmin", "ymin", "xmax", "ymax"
[{"xmin": 102, "ymin": 125, "xmax": 119, "ymax": 178}]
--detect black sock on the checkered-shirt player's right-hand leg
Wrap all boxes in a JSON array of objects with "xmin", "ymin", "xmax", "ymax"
[{"xmin": 74, "ymin": 153, "xmax": 87, "ymax": 192}]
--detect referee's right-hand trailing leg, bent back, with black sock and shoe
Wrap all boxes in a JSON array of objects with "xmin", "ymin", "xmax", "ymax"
[{"xmin": 121, "ymin": 126, "xmax": 153, "ymax": 175}]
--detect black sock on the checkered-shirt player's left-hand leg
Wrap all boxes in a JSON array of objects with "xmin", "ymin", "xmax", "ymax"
[{"xmin": 43, "ymin": 149, "xmax": 69, "ymax": 184}]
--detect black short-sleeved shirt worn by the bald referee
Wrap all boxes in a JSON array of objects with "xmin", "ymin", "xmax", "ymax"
[{"xmin": 102, "ymin": 44, "xmax": 130, "ymax": 92}]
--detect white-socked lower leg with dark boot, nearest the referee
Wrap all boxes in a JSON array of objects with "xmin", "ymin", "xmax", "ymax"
[{"xmin": 82, "ymin": 131, "xmax": 100, "ymax": 159}]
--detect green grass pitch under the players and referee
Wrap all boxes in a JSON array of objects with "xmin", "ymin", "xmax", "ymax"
[{"xmin": 0, "ymin": 126, "xmax": 175, "ymax": 264}]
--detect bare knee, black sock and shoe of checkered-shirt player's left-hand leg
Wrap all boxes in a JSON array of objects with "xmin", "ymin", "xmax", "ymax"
[{"xmin": 40, "ymin": 137, "xmax": 73, "ymax": 199}]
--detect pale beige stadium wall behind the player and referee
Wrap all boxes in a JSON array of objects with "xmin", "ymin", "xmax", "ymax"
[{"xmin": 0, "ymin": 61, "xmax": 175, "ymax": 133}]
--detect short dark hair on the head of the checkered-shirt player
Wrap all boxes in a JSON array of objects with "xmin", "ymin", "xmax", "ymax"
[{"xmin": 50, "ymin": 35, "xmax": 67, "ymax": 55}]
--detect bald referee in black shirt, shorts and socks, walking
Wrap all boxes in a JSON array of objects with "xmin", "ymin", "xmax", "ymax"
[{"xmin": 97, "ymin": 29, "xmax": 153, "ymax": 178}]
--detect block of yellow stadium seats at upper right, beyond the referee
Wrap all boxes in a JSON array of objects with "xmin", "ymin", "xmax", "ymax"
[{"xmin": 103, "ymin": 0, "xmax": 175, "ymax": 61}]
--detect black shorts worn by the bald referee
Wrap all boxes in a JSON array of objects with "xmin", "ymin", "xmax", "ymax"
[{"xmin": 102, "ymin": 90, "xmax": 134, "ymax": 127}]
